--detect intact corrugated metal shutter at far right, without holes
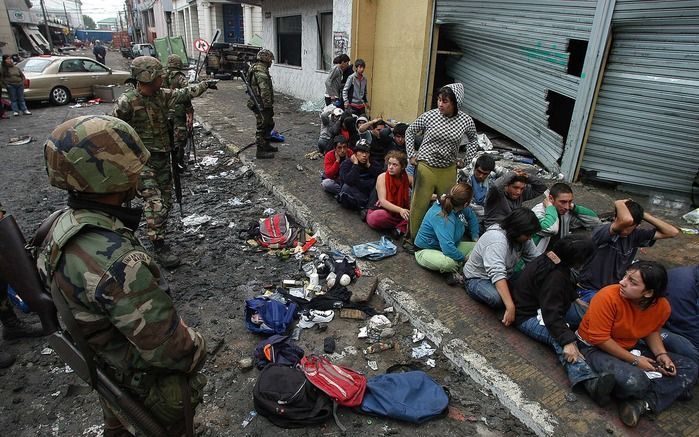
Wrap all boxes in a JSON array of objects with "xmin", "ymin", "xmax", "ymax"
[{"xmin": 582, "ymin": 1, "xmax": 699, "ymax": 193}]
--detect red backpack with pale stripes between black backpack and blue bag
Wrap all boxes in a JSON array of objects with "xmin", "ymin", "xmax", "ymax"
[{"xmin": 300, "ymin": 355, "xmax": 366, "ymax": 407}]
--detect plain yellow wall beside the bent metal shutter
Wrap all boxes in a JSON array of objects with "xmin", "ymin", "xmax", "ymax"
[{"xmin": 351, "ymin": 0, "xmax": 433, "ymax": 122}]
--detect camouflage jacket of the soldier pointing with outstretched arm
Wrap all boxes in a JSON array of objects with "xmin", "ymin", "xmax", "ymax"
[{"xmin": 112, "ymin": 82, "xmax": 207, "ymax": 152}]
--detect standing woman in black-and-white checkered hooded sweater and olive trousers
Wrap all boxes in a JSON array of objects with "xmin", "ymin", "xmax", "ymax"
[{"xmin": 405, "ymin": 83, "xmax": 478, "ymax": 244}]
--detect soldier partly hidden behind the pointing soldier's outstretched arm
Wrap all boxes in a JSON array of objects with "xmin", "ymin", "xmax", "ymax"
[{"xmin": 163, "ymin": 53, "xmax": 194, "ymax": 172}]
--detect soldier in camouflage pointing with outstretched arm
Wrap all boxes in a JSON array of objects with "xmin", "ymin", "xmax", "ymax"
[{"xmin": 112, "ymin": 56, "xmax": 216, "ymax": 268}]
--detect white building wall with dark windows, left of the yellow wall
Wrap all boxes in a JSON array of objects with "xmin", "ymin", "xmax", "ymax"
[{"xmin": 260, "ymin": 0, "xmax": 352, "ymax": 102}]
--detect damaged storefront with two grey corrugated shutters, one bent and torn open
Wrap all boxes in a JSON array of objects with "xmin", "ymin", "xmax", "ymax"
[{"xmin": 434, "ymin": 0, "xmax": 699, "ymax": 194}]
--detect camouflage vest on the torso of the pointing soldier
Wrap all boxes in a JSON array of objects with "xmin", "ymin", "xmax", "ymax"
[{"xmin": 124, "ymin": 89, "xmax": 171, "ymax": 152}]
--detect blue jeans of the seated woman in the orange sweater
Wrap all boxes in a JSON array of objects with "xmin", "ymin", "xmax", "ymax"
[{"xmin": 578, "ymin": 341, "xmax": 698, "ymax": 413}]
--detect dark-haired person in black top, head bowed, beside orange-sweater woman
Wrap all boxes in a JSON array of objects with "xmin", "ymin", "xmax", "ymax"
[{"xmin": 512, "ymin": 235, "xmax": 614, "ymax": 405}]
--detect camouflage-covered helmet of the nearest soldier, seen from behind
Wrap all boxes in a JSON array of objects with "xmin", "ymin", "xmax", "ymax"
[{"xmin": 44, "ymin": 115, "xmax": 150, "ymax": 193}]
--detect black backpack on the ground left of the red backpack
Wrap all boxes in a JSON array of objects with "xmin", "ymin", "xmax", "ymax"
[{"xmin": 252, "ymin": 363, "xmax": 332, "ymax": 428}]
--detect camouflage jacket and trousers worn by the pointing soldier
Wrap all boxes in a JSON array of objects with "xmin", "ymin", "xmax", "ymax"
[{"xmin": 111, "ymin": 57, "xmax": 208, "ymax": 244}]
